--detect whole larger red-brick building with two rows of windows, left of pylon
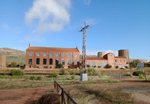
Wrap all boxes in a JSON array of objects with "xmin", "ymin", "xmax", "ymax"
[{"xmin": 26, "ymin": 44, "xmax": 80, "ymax": 68}]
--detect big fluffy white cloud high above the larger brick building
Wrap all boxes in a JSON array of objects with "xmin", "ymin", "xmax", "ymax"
[{"xmin": 25, "ymin": 0, "xmax": 71, "ymax": 33}]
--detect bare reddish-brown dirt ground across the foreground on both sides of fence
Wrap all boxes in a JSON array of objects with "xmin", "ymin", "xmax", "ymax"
[{"xmin": 0, "ymin": 81, "xmax": 150, "ymax": 104}]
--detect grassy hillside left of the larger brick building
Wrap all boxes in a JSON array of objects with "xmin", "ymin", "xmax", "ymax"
[{"xmin": 0, "ymin": 47, "xmax": 26, "ymax": 64}]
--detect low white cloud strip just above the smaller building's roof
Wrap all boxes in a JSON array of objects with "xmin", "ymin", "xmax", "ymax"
[{"xmin": 80, "ymin": 50, "xmax": 118, "ymax": 56}]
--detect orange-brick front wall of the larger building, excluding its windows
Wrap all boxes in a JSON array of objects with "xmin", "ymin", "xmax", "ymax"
[{"xmin": 26, "ymin": 51, "xmax": 80, "ymax": 68}]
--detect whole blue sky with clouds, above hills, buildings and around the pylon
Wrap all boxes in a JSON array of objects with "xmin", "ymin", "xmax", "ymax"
[{"xmin": 0, "ymin": 0, "xmax": 150, "ymax": 60}]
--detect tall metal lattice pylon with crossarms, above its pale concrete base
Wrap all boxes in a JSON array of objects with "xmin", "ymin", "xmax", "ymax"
[{"xmin": 79, "ymin": 22, "xmax": 89, "ymax": 68}]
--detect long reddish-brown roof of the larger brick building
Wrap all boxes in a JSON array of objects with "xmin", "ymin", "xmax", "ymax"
[{"xmin": 26, "ymin": 46, "xmax": 79, "ymax": 52}]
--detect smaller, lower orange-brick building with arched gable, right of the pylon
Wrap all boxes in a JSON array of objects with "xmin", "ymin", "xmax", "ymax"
[{"xmin": 86, "ymin": 53, "xmax": 128, "ymax": 69}]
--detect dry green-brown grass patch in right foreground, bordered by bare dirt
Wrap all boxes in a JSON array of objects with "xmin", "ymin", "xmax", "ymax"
[{"xmin": 77, "ymin": 85, "xmax": 133, "ymax": 104}]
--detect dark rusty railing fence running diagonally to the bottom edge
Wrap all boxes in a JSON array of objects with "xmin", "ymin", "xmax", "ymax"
[{"xmin": 54, "ymin": 81, "xmax": 77, "ymax": 104}]
